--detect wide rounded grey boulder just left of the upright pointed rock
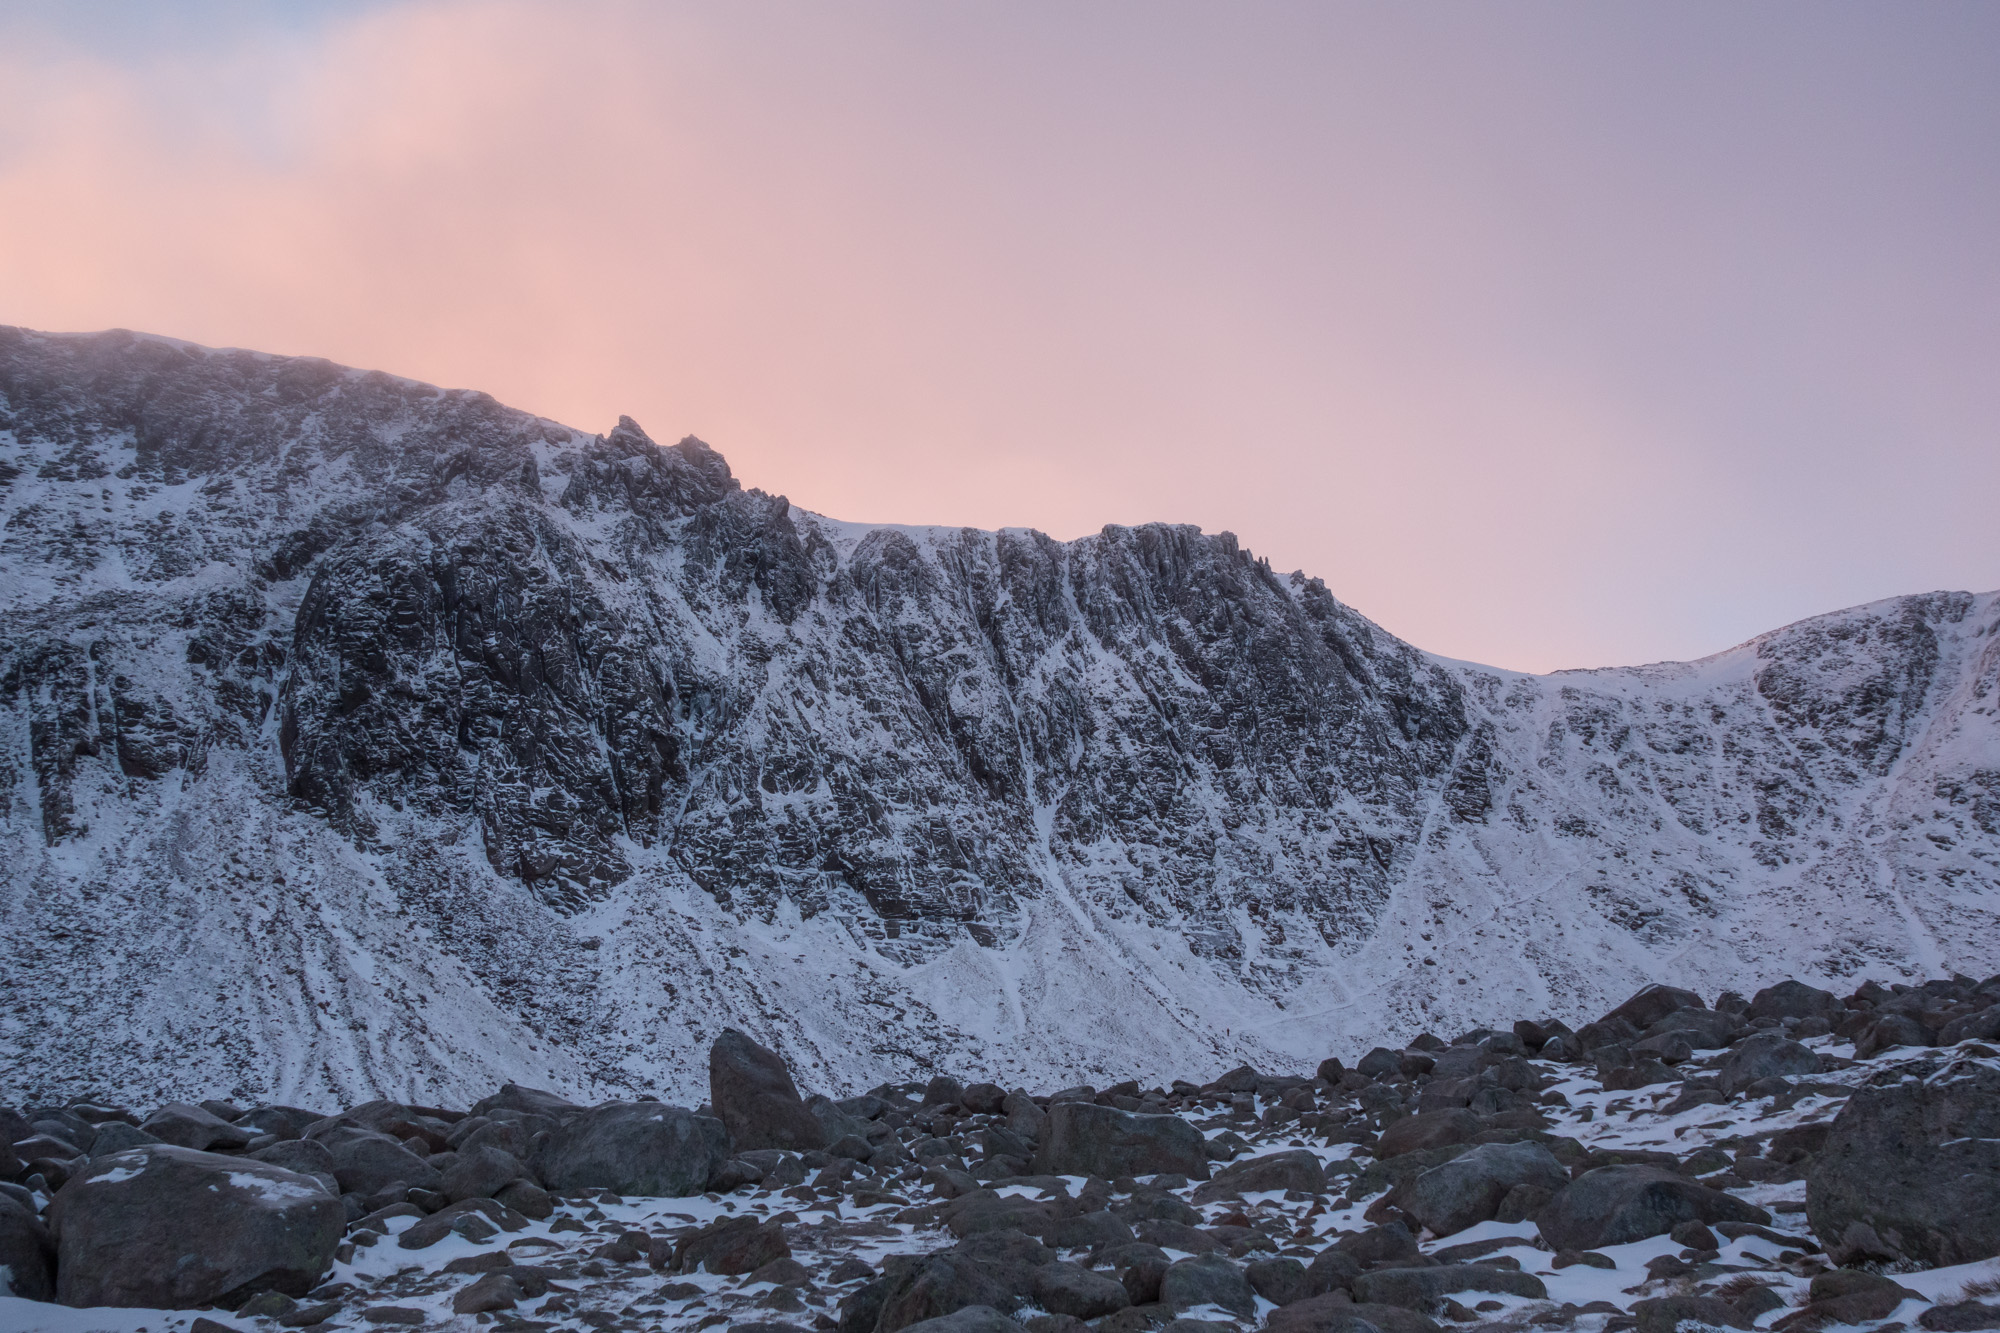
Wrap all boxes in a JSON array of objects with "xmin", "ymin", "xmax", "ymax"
[{"xmin": 534, "ymin": 1101, "xmax": 730, "ymax": 1197}]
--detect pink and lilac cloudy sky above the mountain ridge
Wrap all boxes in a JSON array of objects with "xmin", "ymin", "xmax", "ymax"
[{"xmin": 0, "ymin": 0, "xmax": 2000, "ymax": 671}]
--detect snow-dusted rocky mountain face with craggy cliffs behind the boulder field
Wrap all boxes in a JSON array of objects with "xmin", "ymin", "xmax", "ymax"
[{"xmin": 0, "ymin": 328, "xmax": 2000, "ymax": 1101}]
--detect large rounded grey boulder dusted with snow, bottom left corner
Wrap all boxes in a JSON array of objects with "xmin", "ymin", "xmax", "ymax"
[{"xmin": 48, "ymin": 1145, "xmax": 346, "ymax": 1309}]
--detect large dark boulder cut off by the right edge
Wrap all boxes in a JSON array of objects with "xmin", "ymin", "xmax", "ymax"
[{"xmin": 1806, "ymin": 1063, "xmax": 2000, "ymax": 1267}]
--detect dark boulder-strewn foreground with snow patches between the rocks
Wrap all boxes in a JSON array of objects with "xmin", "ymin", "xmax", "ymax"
[{"xmin": 0, "ymin": 964, "xmax": 2000, "ymax": 1333}]
